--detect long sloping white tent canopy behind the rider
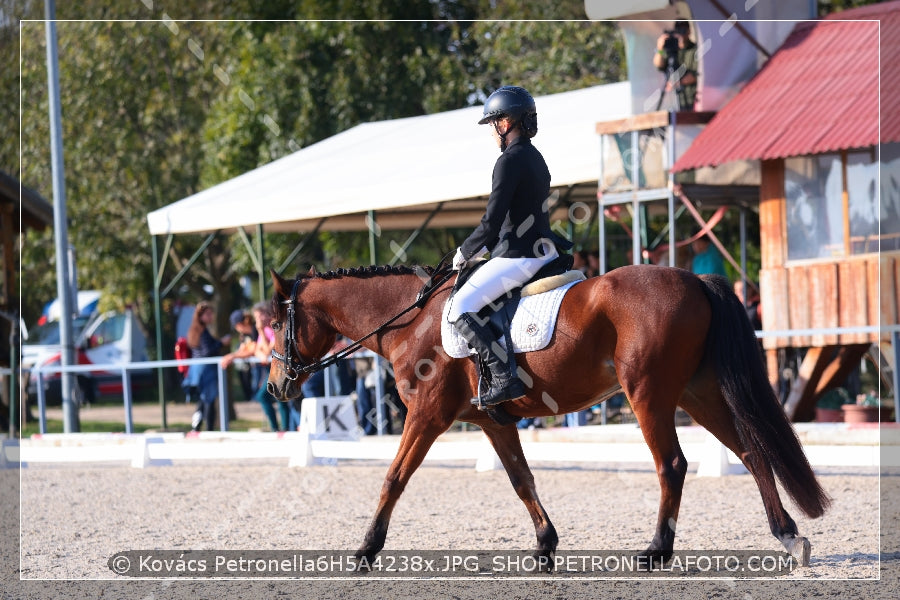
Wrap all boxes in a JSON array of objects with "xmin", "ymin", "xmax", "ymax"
[{"xmin": 147, "ymin": 82, "xmax": 631, "ymax": 235}]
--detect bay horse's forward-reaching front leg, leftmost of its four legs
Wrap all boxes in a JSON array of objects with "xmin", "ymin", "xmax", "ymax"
[{"xmin": 356, "ymin": 409, "xmax": 452, "ymax": 562}]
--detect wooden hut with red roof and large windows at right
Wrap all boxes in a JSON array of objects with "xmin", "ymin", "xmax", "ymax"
[{"xmin": 672, "ymin": 2, "xmax": 900, "ymax": 420}]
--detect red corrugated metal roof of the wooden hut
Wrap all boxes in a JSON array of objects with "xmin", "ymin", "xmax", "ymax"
[{"xmin": 672, "ymin": 1, "xmax": 900, "ymax": 171}]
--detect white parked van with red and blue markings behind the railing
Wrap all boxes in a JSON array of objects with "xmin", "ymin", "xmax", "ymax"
[{"xmin": 22, "ymin": 310, "xmax": 152, "ymax": 404}]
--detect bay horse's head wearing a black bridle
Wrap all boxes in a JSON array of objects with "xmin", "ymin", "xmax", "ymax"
[{"xmin": 266, "ymin": 269, "xmax": 336, "ymax": 401}]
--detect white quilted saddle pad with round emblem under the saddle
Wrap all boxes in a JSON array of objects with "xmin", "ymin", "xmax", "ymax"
[{"xmin": 441, "ymin": 280, "xmax": 580, "ymax": 358}]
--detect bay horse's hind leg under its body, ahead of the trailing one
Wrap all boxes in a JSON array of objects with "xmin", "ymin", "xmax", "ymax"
[{"xmin": 629, "ymin": 392, "xmax": 687, "ymax": 564}]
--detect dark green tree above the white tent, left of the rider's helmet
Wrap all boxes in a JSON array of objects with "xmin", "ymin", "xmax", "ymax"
[{"xmin": 197, "ymin": 16, "xmax": 478, "ymax": 268}]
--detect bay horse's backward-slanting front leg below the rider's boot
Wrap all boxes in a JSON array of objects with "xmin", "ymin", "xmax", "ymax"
[{"xmin": 481, "ymin": 424, "xmax": 559, "ymax": 570}]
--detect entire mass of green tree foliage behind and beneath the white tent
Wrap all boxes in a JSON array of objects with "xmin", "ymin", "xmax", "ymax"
[{"xmin": 0, "ymin": 0, "xmax": 624, "ymax": 338}]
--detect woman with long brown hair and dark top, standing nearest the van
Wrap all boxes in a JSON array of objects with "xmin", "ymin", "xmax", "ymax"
[{"xmin": 182, "ymin": 302, "xmax": 231, "ymax": 431}]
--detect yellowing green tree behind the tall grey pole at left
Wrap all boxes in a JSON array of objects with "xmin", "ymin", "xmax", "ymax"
[{"xmin": 21, "ymin": 22, "xmax": 237, "ymax": 338}]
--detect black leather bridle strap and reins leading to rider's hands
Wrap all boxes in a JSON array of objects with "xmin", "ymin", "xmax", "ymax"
[{"xmin": 272, "ymin": 253, "xmax": 454, "ymax": 381}]
